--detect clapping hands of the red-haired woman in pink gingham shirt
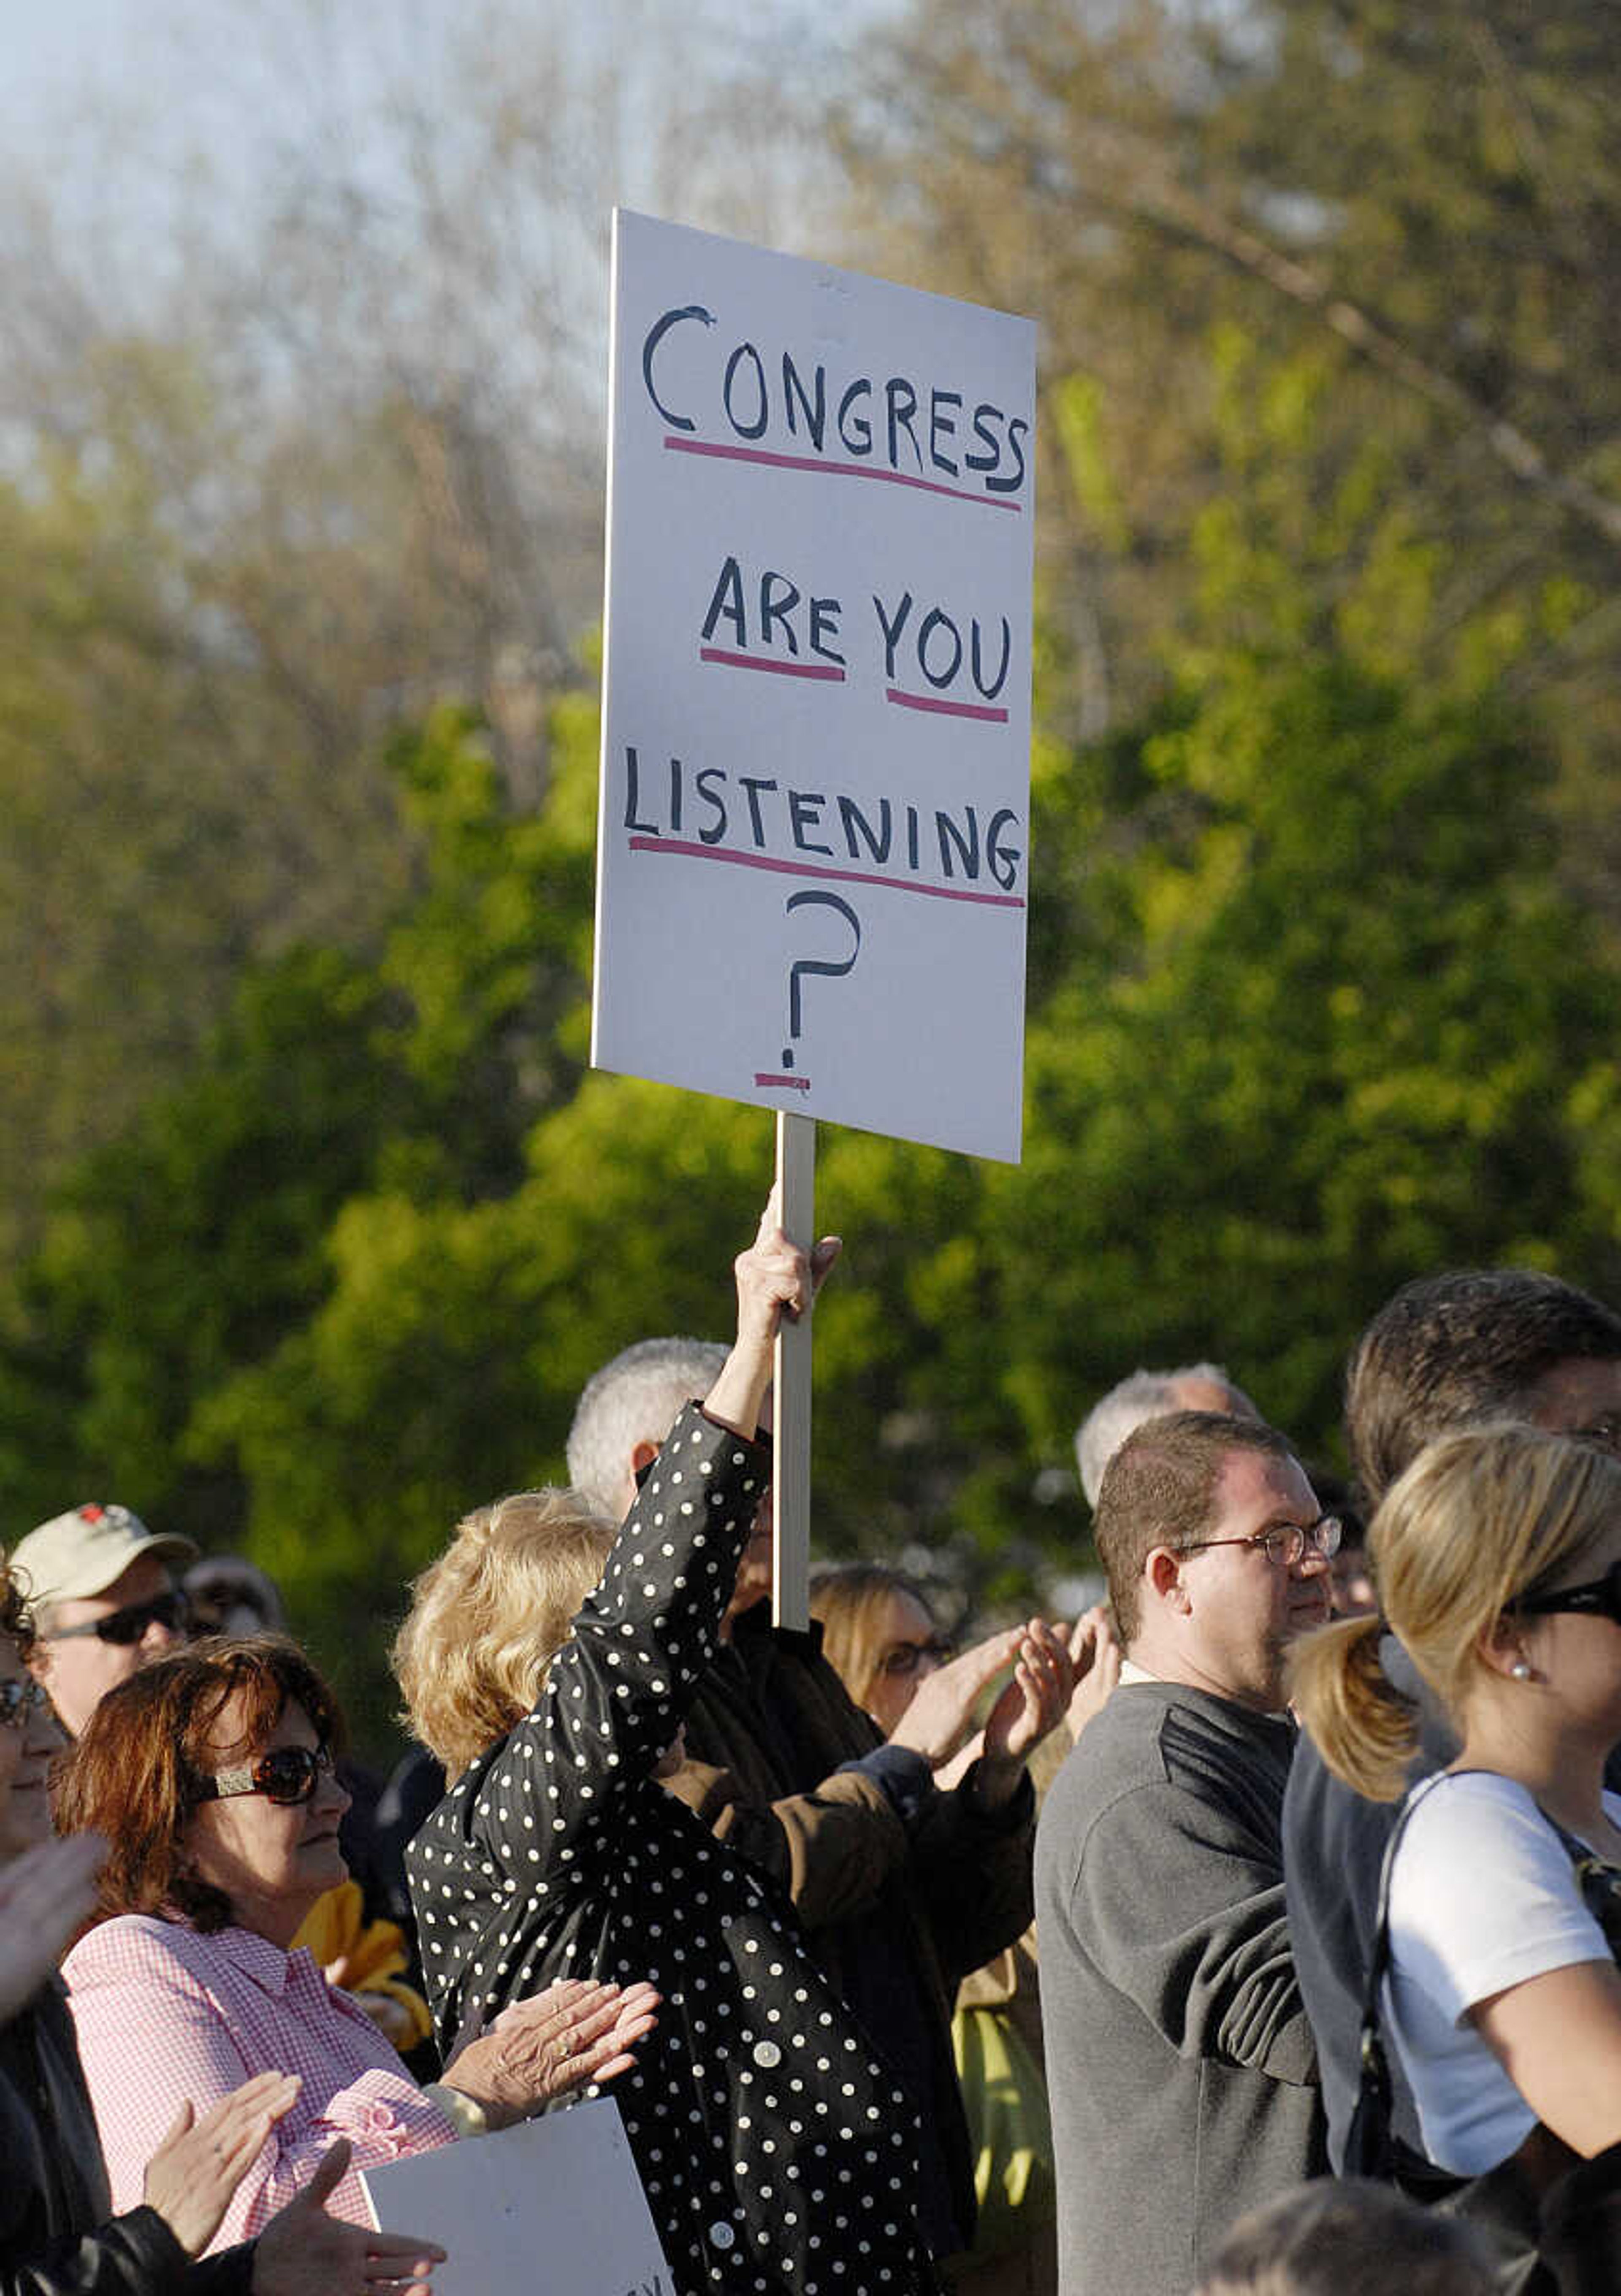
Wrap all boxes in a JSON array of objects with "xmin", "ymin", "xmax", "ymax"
[{"xmin": 443, "ymin": 1977, "xmax": 659, "ymax": 2128}]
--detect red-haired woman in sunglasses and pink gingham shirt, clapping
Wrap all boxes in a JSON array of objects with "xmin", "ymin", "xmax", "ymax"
[{"xmin": 57, "ymin": 1635, "xmax": 654, "ymax": 2245}]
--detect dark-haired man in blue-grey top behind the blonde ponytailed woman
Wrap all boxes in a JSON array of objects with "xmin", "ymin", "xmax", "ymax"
[{"xmin": 1283, "ymin": 1267, "xmax": 1621, "ymax": 2165}]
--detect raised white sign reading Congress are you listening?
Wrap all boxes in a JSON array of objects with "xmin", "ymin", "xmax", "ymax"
[{"xmin": 592, "ymin": 211, "xmax": 1035, "ymax": 1162}]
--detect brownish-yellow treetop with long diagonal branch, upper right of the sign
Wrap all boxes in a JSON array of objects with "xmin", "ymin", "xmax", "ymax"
[{"xmin": 838, "ymin": 0, "xmax": 1621, "ymax": 909}]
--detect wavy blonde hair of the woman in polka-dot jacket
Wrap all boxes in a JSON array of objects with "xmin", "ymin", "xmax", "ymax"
[{"xmin": 390, "ymin": 1490, "xmax": 613, "ymax": 1782}]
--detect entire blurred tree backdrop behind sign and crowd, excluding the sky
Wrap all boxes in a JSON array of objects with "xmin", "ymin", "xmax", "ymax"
[{"xmin": 0, "ymin": 0, "xmax": 1621, "ymax": 1733}]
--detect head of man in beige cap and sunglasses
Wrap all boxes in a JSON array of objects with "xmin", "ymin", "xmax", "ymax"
[{"xmin": 11, "ymin": 1502, "xmax": 198, "ymax": 1738}]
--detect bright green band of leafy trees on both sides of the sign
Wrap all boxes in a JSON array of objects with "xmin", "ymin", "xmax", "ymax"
[{"xmin": 0, "ymin": 583, "xmax": 1621, "ymax": 1733}]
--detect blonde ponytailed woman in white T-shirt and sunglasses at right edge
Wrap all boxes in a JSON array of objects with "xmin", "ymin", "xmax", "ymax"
[{"xmin": 1293, "ymin": 1426, "xmax": 1621, "ymax": 2195}]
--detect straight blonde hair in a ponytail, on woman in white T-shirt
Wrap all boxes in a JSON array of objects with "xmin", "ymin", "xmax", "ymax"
[{"xmin": 1290, "ymin": 1426, "xmax": 1621, "ymax": 1802}]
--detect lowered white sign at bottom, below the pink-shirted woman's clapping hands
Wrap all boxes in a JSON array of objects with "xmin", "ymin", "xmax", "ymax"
[{"xmin": 361, "ymin": 2096, "xmax": 675, "ymax": 2296}]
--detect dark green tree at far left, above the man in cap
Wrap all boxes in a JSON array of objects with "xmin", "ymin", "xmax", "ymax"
[{"xmin": 0, "ymin": 950, "xmax": 418, "ymax": 1545}]
